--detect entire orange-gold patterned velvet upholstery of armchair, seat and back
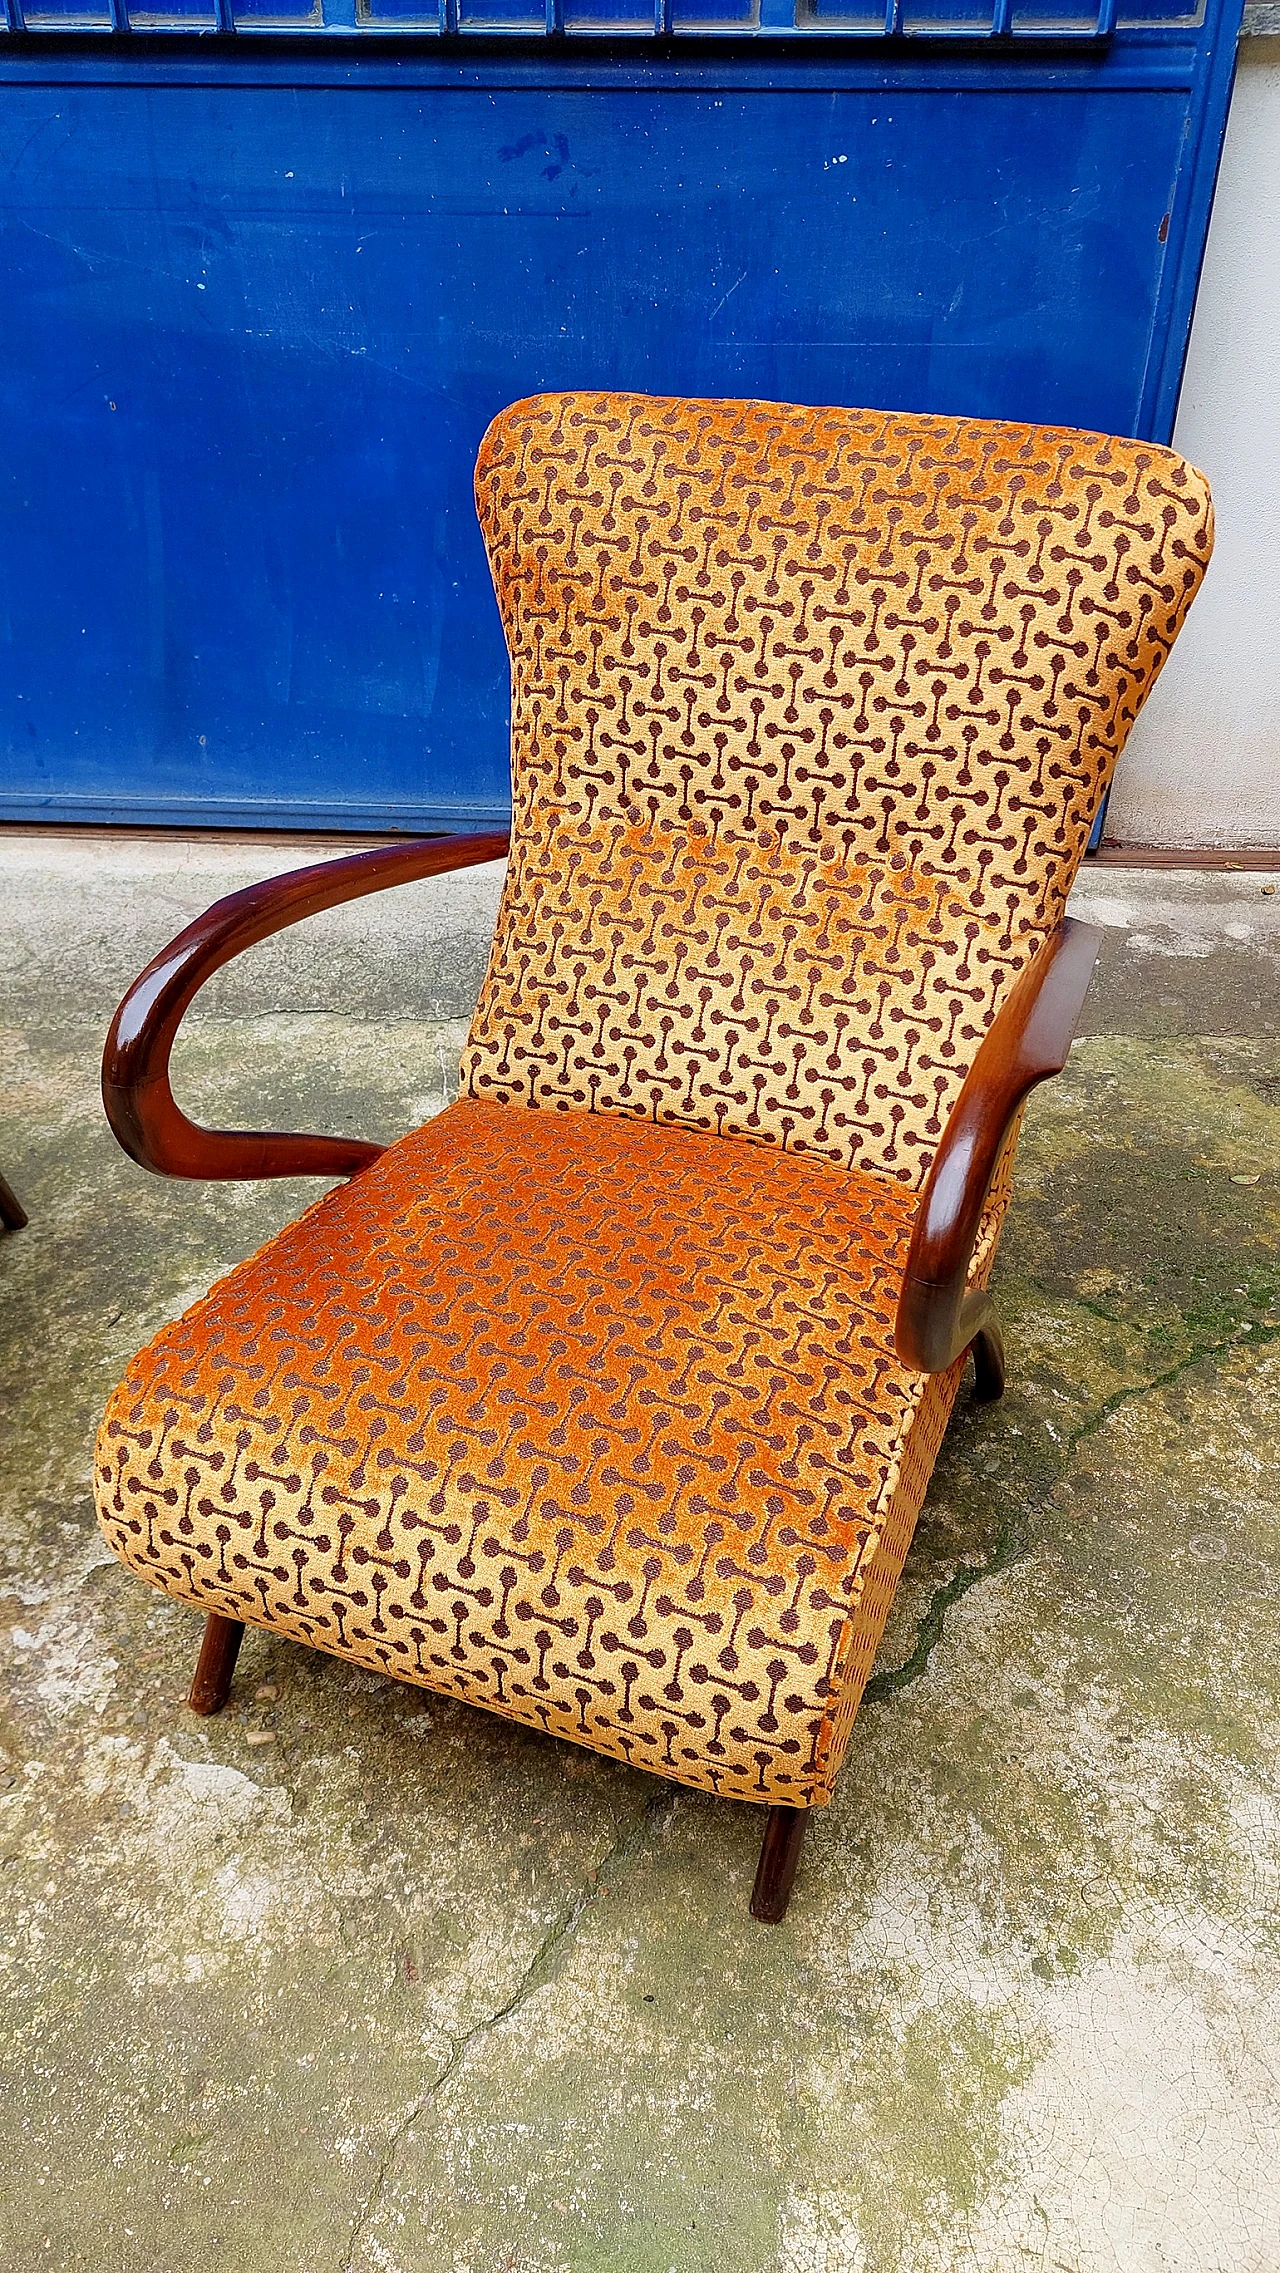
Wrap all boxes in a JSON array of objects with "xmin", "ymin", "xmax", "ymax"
[{"xmin": 98, "ymin": 396, "xmax": 1212, "ymax": 1805}]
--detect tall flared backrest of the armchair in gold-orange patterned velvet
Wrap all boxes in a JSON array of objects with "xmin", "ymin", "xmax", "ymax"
[{"xmin": 464, "ymin": 396, "xmax": 1212, "ymax": 1184}]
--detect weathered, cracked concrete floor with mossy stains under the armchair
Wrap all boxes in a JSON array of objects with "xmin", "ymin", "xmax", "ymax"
[{"xmin": 0, "ymin": 832, "xmax": 1280, "ymax": 2273}]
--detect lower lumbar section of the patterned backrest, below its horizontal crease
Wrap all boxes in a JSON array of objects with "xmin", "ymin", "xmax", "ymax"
[{"xmin": 462, "ymin": 821, "xmax": 1039, "ymax": 1187}]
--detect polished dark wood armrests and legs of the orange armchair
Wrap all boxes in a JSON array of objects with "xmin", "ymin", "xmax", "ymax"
[{"xmin": 102, "ymin": 832, "xmax": 1103, "ymax": 1925}]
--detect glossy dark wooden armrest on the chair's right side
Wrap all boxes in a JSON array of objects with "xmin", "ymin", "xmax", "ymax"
[{"xmin": 893, "ymin": 916, "xmax": 1103, "ymax": 1373}]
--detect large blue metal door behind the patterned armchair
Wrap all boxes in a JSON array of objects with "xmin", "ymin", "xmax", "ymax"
[{"xmin": 0, "ymin": 0, "xmax": 1239, "ymax": 830}]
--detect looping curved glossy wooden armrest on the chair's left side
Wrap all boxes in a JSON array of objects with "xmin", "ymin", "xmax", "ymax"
[{"xmin": 102, "ymin": 830, "xmax": 509, "ymax": 1182}]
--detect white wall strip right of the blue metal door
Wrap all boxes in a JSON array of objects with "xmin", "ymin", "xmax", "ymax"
[{"xmin": 1107, "ymin": 39, "xmax": 1280, "ymax": 846}]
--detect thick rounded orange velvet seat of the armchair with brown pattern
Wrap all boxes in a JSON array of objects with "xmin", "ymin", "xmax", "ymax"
[{"xmin": 98, "ymin": 1100, "xmax": 957, "ymax": 1805}]
